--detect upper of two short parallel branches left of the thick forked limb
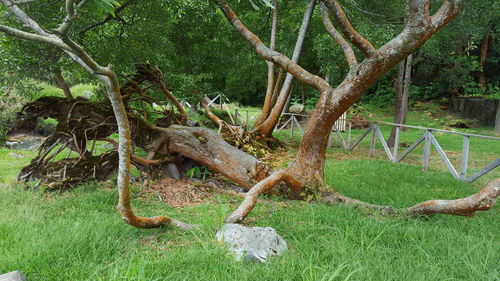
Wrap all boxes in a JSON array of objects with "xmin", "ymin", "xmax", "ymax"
[{"xmin": 321, "ymin": 0, "xmax": 378, "ymax": 58}]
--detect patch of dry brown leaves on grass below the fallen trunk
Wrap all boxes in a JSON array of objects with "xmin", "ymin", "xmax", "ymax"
[{"xmin": 147, "ymin": 179, "xmax": 212, "ymax": 208}]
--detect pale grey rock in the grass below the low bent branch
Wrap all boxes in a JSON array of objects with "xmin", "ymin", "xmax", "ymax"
[{"xmin": 215, "ymin": 223, "xmax": 288, "ymax": 262}]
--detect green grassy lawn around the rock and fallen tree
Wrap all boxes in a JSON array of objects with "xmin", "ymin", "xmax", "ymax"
[{"xmin": 0, "ymin": 103, "xmax": 500, "ymax": 280}]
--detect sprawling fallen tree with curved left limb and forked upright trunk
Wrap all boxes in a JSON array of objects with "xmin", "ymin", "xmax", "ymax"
[{"xmin": 0, "ymin": 0, "xmax": 500, "ymax": 229}]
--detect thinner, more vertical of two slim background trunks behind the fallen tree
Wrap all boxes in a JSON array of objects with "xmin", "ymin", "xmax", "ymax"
[{"xmin": 255, "ymin": 0, "xmax": 279, "ymax": 126}]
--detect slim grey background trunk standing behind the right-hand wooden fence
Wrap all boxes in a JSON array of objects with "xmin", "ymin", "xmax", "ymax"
[{"xmin": 387, "ymin": 55, "xmax": 412, "ymax": 147}]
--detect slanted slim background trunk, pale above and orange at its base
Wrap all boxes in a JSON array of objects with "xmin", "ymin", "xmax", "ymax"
[{"xmin": 254, "ymin": 0, "xmax": 316, "ymax": 137}]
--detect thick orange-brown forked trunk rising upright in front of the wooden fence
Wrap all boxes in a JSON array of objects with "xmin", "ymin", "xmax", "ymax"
[{"xmin": 215, "ymin": 0, "xmax": 500, "ymax": 222}]
